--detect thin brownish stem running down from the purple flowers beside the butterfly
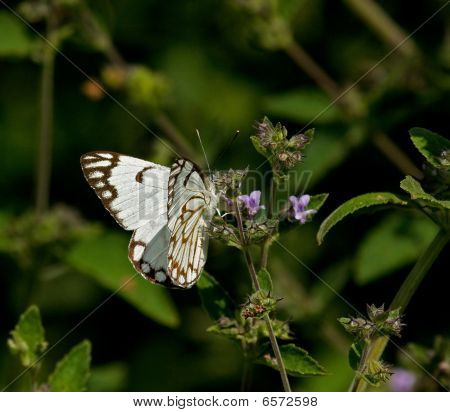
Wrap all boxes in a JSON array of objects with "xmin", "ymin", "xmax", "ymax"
[{"xmin": 234, "ymin": 199, "xmax": 291, "ymax": 392}]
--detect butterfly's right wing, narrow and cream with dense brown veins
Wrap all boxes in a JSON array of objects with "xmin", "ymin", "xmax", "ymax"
[{"xmin": 167, "ymin": 159, "xmax": 217, "ymax": 288}]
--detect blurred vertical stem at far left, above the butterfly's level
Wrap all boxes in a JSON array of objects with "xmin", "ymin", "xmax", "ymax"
[{"xmin": 36, "ymin": 11, "xmax": 55, "ymax": 218}]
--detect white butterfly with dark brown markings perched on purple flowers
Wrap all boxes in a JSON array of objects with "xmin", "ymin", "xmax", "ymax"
[{"xmin": 81, "ymin": 151, "xmax": 219, "ymax": 288}]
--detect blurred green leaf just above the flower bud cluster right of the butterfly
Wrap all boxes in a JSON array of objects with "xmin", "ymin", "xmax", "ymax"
[{"xmin": 264, "ymin": 89, "xmax": 340, "ymax": 124}]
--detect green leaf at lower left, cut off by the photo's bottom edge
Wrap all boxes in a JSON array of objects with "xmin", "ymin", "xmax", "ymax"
[{"xmin": 48, "ymin": 340, "xmax": 91, "ymax": 392}]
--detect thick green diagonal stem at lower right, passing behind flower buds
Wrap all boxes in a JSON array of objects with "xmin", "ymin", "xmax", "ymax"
[{"xmin": 354, "ymin": 229, "xmax": 450, "ymax": 392}]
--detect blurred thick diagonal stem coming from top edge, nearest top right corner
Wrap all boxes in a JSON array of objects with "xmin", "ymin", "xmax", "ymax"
[{"xmin": 344, "ymin": 0, "xmax": 418, "ymax": 57}]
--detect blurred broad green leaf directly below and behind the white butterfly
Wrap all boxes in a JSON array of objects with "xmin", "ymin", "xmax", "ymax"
[{"xmin": 67, "ymin": 231, "xmax": 179, "ymax": 327}]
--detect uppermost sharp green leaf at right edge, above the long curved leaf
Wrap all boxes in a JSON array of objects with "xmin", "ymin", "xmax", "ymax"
[{"xmin": 409, "ymin": 127, "xmax": 450, "ymax": 169}]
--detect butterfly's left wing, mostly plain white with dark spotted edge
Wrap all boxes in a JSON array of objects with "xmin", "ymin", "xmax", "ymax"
[{"xmin": 81, "ymin": 152, "xmax": 171, "ymax": 285}]
